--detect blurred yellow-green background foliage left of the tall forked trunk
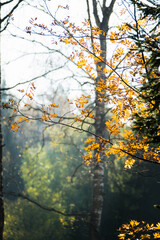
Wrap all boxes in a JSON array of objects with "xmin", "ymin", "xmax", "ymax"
[{"xmin": 5, "ymin": 129, "xmax": 91, "ymax": 240}]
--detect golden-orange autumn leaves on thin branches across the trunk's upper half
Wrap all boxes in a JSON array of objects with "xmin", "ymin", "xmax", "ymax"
[{"xmin": 6, "ymin": 1, "xmax": 160, "ymax": 168}]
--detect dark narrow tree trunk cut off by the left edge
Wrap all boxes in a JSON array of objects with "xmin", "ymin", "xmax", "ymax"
[{"xmin": 0, "ymin": 5, "xmax": 4, "ymax": 240}]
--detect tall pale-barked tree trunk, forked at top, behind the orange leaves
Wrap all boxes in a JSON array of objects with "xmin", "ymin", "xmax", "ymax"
[{"xmin": 90, "ymin": 0, "xmax": 116, "ymax": 240}]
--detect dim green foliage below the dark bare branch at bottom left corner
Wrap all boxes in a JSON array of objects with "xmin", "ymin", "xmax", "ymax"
[{"xmin": 4, "ymin": 199, "xmax": 67, "ymax": 240}]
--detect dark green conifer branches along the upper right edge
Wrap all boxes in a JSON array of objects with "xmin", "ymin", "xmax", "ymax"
[{"xmin": 130, "ymin": 0, "xmax": 160, "ymax": 145}]
